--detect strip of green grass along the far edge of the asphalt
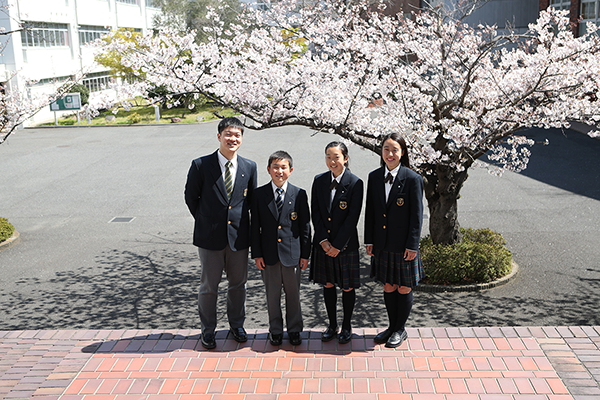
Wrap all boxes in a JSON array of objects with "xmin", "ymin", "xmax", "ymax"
[{"xmin": 38, "ymin": 98, "xmax": 237, "ymax": 126}]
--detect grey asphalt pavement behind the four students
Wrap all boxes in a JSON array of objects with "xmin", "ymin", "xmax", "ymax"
[{"xmin": 0, "ymin": 122, "xmax": 600, "ymax": 330}]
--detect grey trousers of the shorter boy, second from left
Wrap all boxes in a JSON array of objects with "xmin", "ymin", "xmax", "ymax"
[{"xmin": 261, "ymin": 262, "xmax": 304, "ymax": 334}]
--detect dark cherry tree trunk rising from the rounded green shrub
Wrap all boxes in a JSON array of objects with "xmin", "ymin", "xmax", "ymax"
[{"xmin": 424, "ymin": 165, "xmax": 468, "ymax": 244}]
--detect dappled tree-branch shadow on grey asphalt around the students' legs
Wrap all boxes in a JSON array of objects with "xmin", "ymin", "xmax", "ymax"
[{"xmin": 0, "ymin": 241, "xmax": 600, "ymax": 330}]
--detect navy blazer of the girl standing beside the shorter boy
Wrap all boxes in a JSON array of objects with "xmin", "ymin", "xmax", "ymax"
[{"xmin": 311, "ymin": 169, "xmax": 364, "ymax": 251}]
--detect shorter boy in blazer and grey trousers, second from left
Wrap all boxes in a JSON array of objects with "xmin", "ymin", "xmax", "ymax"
[{"xmin": 252, "ymin": 151, "xmax": 310, "ymax": 346}]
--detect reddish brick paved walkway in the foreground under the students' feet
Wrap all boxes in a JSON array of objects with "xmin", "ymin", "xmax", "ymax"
[{"xmin": 0, "ymin": 326, "xmax": 600, "ymax": 400}]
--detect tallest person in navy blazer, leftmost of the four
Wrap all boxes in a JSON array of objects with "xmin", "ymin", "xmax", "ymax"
[{"xmin": 185, "ymin": 117, "xmax": 257, "ymax": 349}]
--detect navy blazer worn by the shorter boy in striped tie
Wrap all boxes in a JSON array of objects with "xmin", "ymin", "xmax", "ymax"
[{"xmin": 252, "ymin": 182, "xmax": 311, "ymax": 267}]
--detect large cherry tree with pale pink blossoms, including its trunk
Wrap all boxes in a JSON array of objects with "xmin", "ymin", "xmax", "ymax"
[{"xmin": 92, "ymin": 0, "xmax": 600, "ymax": 243}]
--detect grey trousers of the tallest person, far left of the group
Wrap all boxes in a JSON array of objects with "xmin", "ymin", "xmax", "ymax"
[{"xmin": 198, "ymin": 246, "xmax": 248, "ymax": 334}]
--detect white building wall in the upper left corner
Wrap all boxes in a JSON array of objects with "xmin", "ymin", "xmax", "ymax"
[{"xmin": 0, "ymin": 0, "xmax": 159, "ymax": 125}]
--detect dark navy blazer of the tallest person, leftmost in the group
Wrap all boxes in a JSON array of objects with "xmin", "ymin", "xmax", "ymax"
[{"xmin": 184, "ymin": 150, "xmax": 257, "ymax": 251}]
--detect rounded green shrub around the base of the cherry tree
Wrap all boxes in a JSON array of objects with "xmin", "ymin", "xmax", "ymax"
[{"xmin": 420, "ymin": 228, "xmax": 512, "ymax": 285}]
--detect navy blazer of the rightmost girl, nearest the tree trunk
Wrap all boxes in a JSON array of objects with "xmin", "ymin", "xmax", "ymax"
[{"xmin": 365, "ymin": 166, "xmax": 423, "ymax": 253}]
